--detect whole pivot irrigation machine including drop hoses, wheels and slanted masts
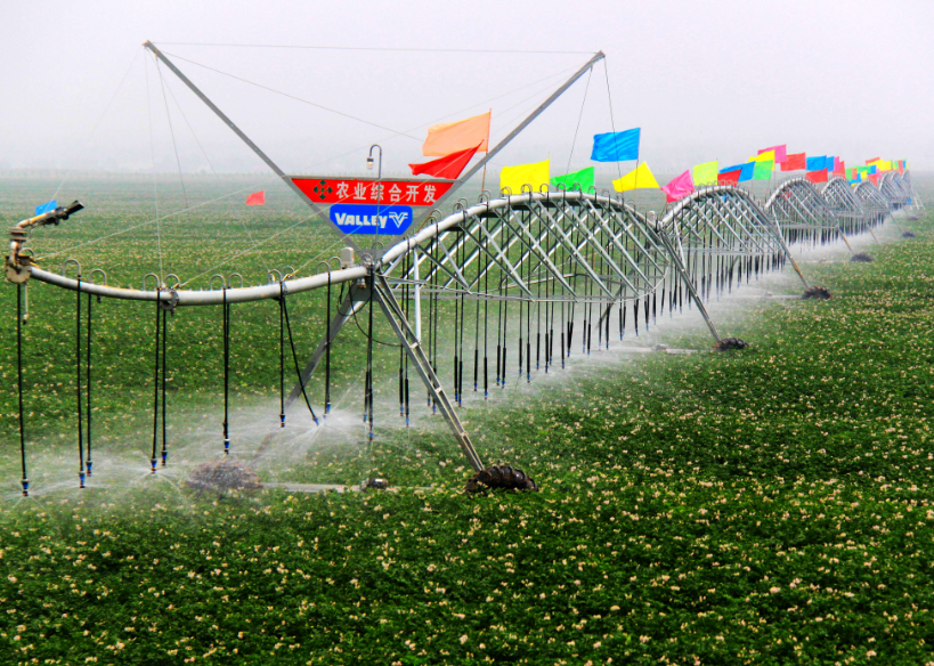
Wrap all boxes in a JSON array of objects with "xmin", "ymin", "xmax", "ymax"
[{"xmin": 6, "ymin": 42, "xmax": 923, "ymax": 495}]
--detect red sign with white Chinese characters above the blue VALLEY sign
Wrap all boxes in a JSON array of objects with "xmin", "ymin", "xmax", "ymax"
[{"xmin": 290, "ymin": 176, "xmax": 454, "ymax": 206}]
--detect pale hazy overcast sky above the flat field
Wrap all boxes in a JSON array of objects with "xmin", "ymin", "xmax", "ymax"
[{"xmin": 0, "ymin": 0, "xmax": 934, "ymax": 175}]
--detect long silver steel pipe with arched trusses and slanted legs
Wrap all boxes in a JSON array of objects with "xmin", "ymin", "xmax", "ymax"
[{"xmin": 18, "ymin": 174, "xmax": 920, "ymax": 469}]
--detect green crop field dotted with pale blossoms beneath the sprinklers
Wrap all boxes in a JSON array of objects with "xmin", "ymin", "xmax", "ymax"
[{"xmin": 0, "ymin": 172, "xmax": 934, "ymax": 666}]
